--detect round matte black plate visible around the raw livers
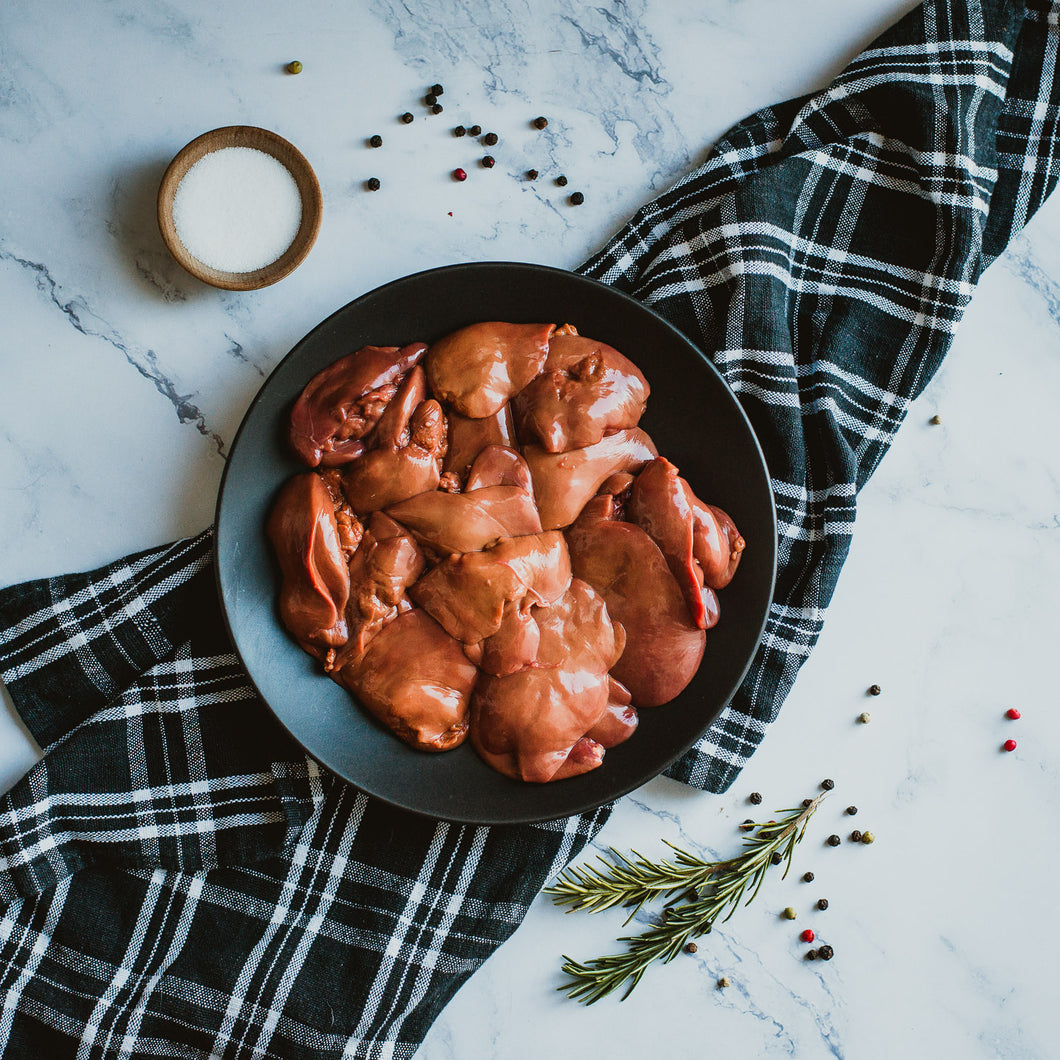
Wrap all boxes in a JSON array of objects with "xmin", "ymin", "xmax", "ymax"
[{"xmin": 215, "ymin": 262, "xmax": 776, "ymax": 824}]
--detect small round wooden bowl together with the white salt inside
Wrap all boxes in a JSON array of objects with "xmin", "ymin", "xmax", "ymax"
[{"xmin": 158, "ymin": 125, "xmax": 321, "ymax": 290}]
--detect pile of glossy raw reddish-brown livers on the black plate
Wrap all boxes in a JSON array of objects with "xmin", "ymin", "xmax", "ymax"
[{"xmin": 267, "ymin": 321, "xmax": 744, "ymax": 782}]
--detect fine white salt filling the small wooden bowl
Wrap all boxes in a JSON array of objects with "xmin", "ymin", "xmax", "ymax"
[{"xmin": 173, "ymin": 147, "xmax": 302, "ymax": 272}]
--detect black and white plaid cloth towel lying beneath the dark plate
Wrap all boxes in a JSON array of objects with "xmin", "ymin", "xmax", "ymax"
[{"xmin": 0, "ymin": 0, "xmax": 1060, "ymax": 1060}]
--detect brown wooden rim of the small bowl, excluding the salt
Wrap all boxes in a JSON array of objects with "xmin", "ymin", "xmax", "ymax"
[{"xmin": 158, "ymin": 125, "xmax": 323, "ymax": 290}]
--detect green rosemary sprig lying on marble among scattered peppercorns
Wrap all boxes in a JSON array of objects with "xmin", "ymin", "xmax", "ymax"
[{"xmin": 545, "ymin": 795, "xmax": 824, "ymax": 1005}]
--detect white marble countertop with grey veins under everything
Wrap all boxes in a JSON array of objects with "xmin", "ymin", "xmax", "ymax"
[{"xmin": 0, "ymin": 0, "xmax": 1060, "ymax": 1060}]
